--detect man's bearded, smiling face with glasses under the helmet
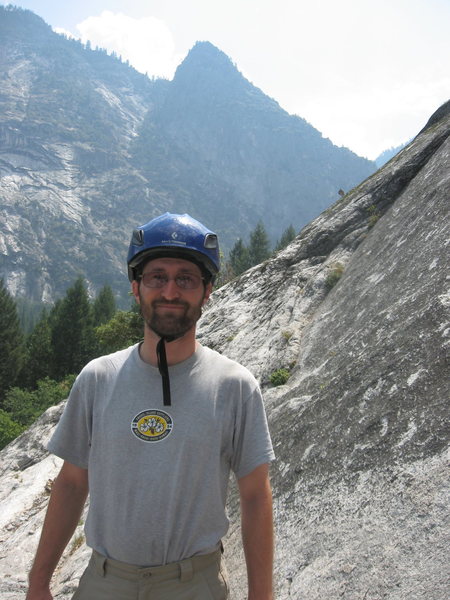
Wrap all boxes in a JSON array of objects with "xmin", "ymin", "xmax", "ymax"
[{"xmin": 133, "ymin": 258, "xmax": 211, "ymax": 338}]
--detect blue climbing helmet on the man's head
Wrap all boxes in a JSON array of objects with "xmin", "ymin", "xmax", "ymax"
[{"xmin": 127, "ymin": 212, "xmax": 220, "ymax": 283}]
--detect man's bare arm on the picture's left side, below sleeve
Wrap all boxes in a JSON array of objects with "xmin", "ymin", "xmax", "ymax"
[{"xmin": 26, "ymin": 462, "xmax": 88, "ymax": 600}]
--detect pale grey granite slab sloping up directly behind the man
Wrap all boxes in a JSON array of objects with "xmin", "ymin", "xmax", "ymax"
[{"xmin": 0, "ymin": 99, "xmax": 450, "ymax": 600}]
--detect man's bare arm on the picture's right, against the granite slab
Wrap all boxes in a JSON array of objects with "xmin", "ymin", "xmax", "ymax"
[{"xmin": 238, "ymin": 464, "xmax": 274, "ymax": 600}]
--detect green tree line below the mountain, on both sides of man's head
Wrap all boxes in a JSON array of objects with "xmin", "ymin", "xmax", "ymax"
[{"xmin": 0, "ymin": 222, "xmax": 296, "ymax": 448}]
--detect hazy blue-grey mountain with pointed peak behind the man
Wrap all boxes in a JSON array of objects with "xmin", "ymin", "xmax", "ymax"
[{"xmin": 0, "ymin": 6, "xmax": 376, "ymax": 308}]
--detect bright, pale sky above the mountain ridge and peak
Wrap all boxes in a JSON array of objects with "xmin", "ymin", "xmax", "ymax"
[{"xmin": 6, "ymin": 0, "xmax": 450, "ymax": 160}]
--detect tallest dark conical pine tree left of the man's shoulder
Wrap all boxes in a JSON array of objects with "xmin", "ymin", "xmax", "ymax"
[{"xmin": 50, "ymin": 277, "xmax": 97, "ymax": 379}]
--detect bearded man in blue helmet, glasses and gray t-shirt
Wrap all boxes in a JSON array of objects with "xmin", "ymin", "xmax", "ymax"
[{"xmin": 27, "ymin": 213, "xmax": 273, "ymax": 600}]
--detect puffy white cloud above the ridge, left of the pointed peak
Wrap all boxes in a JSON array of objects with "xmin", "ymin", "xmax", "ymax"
[{"xmin": 76, "ymin": 10, "xmax": 183, "ymax": 79}]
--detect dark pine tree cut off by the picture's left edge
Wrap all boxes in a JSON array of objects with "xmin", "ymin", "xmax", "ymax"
[{"xmin": 0, "ymin": 279, "xmax": 23, "ymax": 407}]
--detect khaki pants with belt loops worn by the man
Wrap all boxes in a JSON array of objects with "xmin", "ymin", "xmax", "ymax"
[{"xmin": 72, "ymin": 550, "xmax": 229, "ymax": 600}]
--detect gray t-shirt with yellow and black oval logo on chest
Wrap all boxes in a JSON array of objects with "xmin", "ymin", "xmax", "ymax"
[{"xmin": 48, "ymin": 345, "xmax": 274, "ymax": 566}]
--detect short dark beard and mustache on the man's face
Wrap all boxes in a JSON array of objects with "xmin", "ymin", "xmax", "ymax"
[{"xmin": 139, "ymin": 294, "xmax": 203, "ymax": 339}]
